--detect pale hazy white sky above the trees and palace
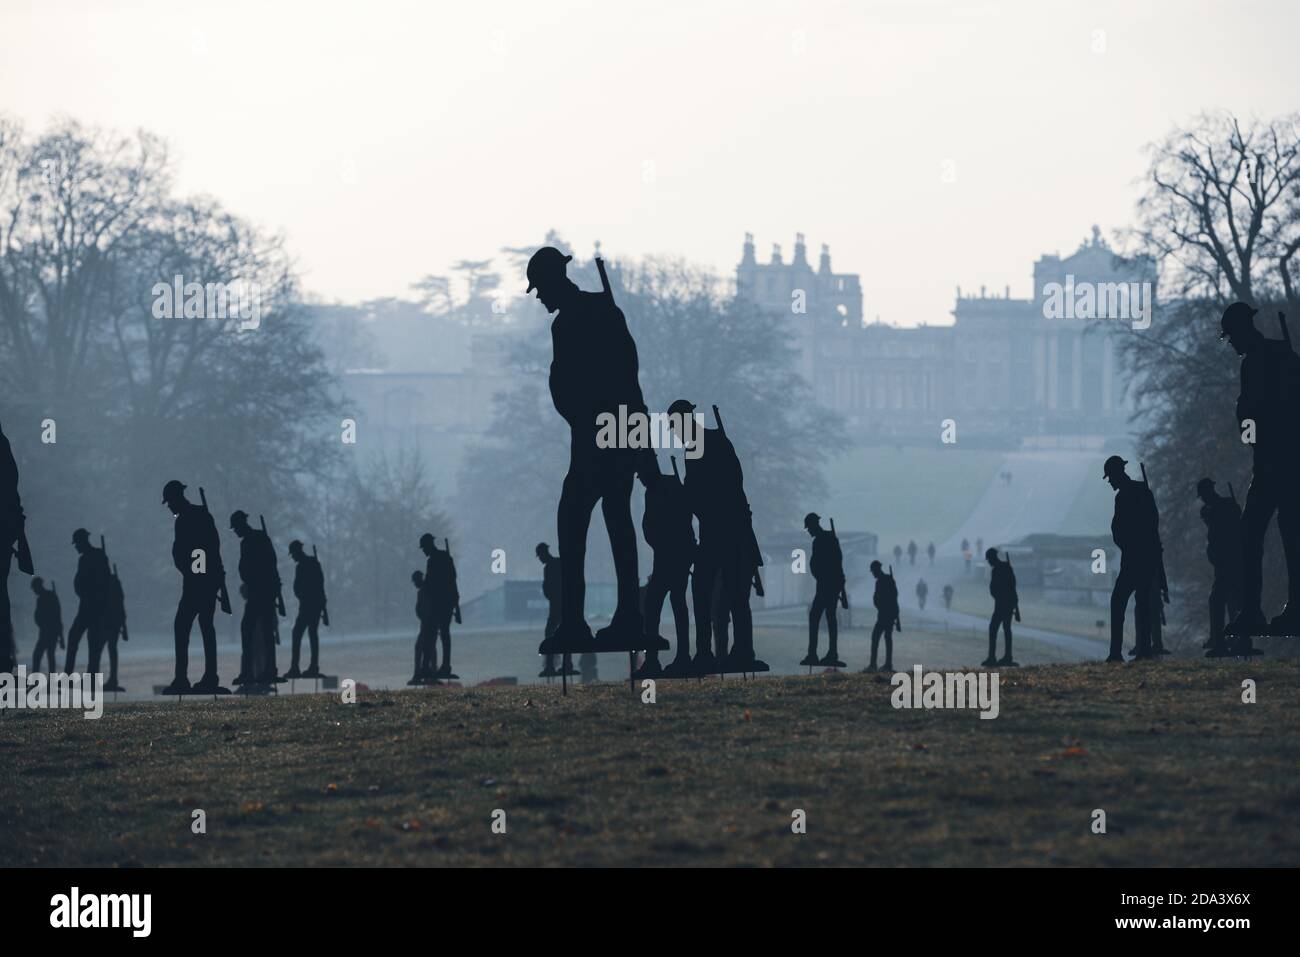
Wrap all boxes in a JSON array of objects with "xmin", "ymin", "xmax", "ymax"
[{"xmin": 0, "ymin": 0, "xmax": 1300, "ymax": 325}]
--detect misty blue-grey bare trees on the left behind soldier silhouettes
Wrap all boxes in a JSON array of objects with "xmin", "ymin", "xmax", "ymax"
[{"xmin": 0, "ymin": 118, "xmax": 447, "ymax": 634}]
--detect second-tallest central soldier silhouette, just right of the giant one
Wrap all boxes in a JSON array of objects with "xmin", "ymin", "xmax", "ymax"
[{"xmin": 668, "ymin": 399, "xmax": 768, "ymax": 674}]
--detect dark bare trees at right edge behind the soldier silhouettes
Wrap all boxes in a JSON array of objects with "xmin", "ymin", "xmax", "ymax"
[{"xmin": 1125, "ymin": 113, "xmax": 1300, "ymax": 646}]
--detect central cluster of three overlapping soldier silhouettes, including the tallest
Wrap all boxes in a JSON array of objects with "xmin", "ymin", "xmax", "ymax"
[{"xmin": 527, "ymin": 246, "xmax": 767, "ymax": 676}]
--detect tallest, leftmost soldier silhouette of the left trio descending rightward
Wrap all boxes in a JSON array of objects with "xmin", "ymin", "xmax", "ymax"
[{"xmin": 163, "ymin": 479, "xmax": 230, "ymax": 694}]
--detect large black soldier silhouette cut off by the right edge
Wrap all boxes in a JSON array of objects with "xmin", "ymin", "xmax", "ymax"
[{"xmin": 1219, "ymin": 303, "xmax": 1300, "ymax": 639}]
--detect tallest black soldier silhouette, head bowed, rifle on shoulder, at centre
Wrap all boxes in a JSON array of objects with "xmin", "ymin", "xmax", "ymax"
[{"xmin": 527, "ymin": 246, "xmax": 654, "ymax": 654}]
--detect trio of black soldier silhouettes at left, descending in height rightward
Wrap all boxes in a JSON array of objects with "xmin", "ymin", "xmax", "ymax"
[{"xmin": 163, "ymin": 479, "xmax": 329, "ymax": 694}]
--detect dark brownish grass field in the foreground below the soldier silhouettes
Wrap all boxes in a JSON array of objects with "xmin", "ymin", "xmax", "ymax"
[{"xmin": 0, "ymin": 661, "xmax": 1300, "ymax": 866}]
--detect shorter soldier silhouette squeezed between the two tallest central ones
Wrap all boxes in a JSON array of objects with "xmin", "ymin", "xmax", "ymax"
[{"xmin": 637, "ymin": 462, "xmax": 696, "ymax": 677}]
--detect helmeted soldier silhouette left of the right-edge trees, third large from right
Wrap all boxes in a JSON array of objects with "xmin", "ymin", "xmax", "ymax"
[{"xmin": 1102, "ymin": 455, "xmax": 1161, "ymax": 662}]
